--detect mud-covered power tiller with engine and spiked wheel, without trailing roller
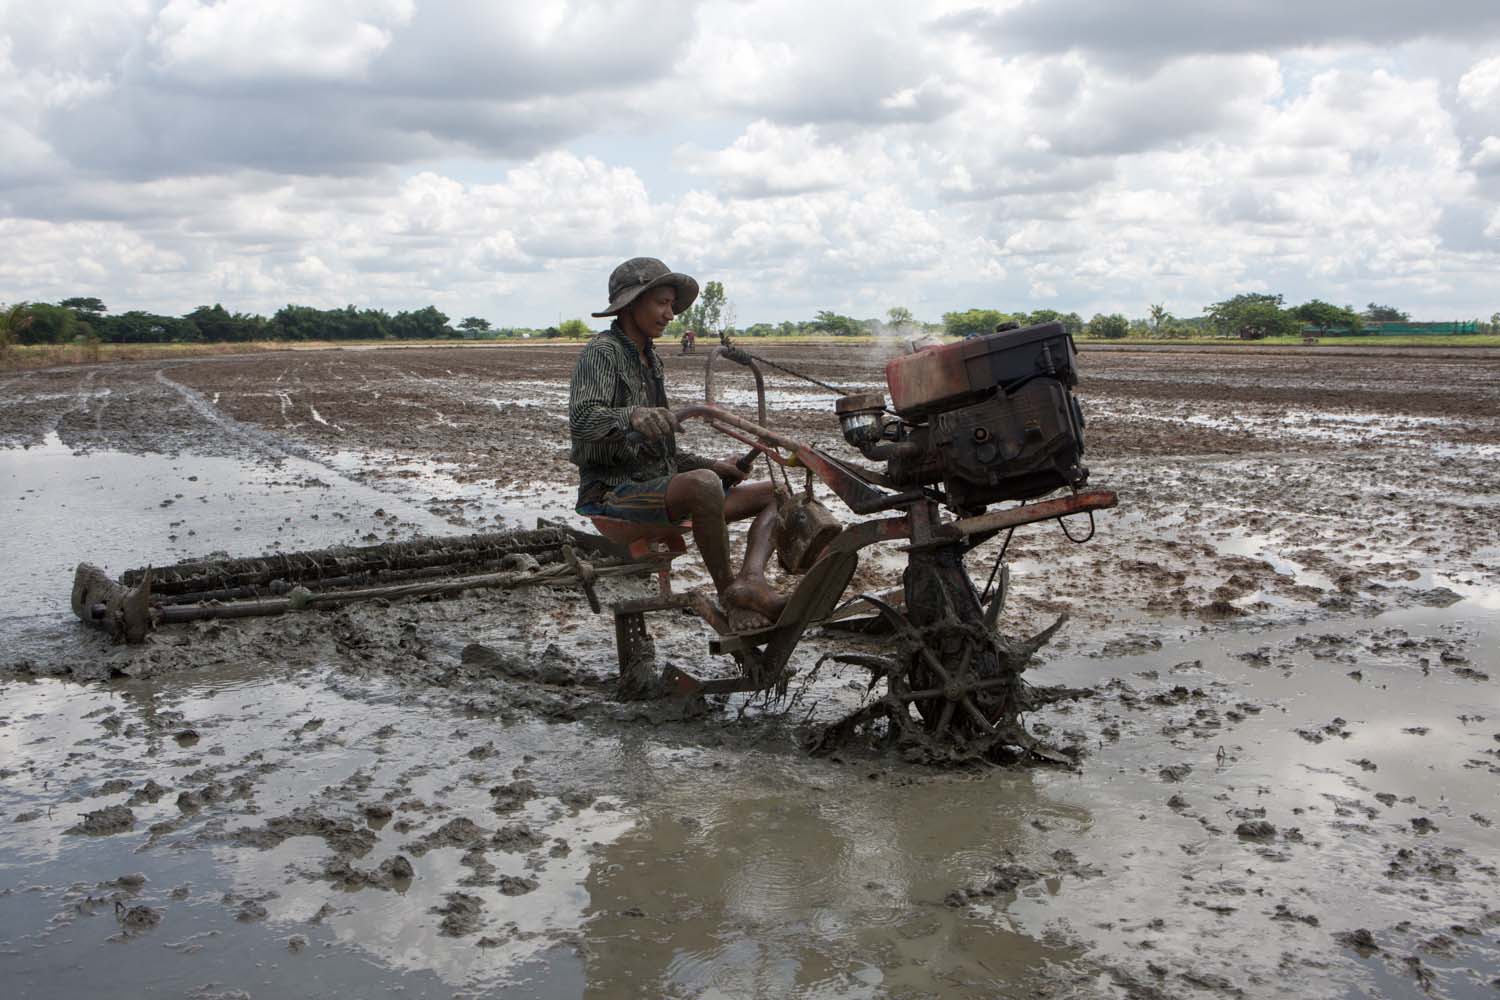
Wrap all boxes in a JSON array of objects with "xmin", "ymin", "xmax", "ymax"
[{"xmin": 615, "ymin": 324, "xmax": 1116, "ymax": 757}]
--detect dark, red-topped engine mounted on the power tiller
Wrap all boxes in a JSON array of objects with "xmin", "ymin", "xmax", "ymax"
[{"xmin": 836, "ymin": 322, "xmax": 1089, "ymax": 513}]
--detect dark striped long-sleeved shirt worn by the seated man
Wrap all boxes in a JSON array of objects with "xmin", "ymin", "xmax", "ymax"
[{"xmin": 567, "ymin": 319, "xmax": 710, "ymax": 501}]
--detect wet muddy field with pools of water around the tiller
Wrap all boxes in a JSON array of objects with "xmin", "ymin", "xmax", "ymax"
[{"xmin": 0, "ymin": 351, "xmax": 1500, "ymax": 997}]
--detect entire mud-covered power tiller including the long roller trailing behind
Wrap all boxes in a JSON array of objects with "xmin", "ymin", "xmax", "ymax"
[{"xmin": 72, "ymin": 324, "xmax": 1115, "ymax": 759}]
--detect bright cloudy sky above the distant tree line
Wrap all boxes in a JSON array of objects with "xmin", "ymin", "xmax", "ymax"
[{"xmin": 0, "ymin": 0, "xmax": 1500, "ymax": 325}]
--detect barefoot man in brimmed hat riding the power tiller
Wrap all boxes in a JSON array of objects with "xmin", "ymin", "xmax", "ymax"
[{"xmin": 569, "ymin": 256, "xmax": 786, "ymax": 628}]
